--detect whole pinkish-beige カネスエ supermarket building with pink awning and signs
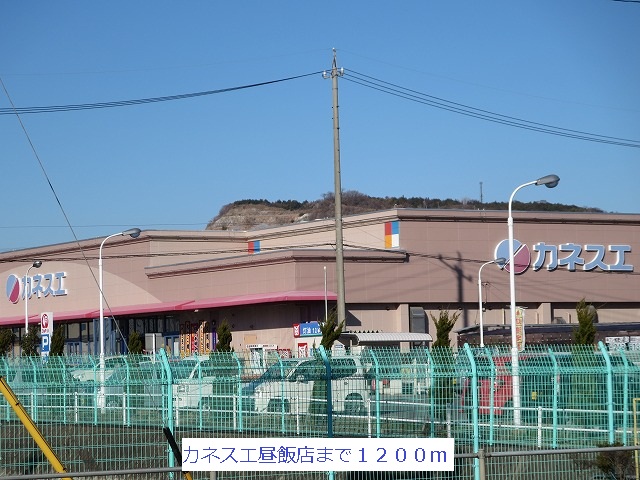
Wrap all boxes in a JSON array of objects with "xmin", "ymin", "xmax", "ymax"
[{"xmin": 0, "ymin": 209, "xmax": 640, "ymax": 356}]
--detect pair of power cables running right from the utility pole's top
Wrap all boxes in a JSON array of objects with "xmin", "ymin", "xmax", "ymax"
[{"xmin": 344, "ymin": 70, "xmax": 640, "ymax": 148}]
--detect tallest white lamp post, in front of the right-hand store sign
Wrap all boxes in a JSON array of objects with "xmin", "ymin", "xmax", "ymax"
[{"xmin": 507, "ymin": 175, "xmax": 560, "ymax": 425}]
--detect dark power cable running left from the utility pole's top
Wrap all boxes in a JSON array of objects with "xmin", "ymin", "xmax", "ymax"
[{"xmin": 0, "ymin": 71, "xmax": 322, "ymax": 115}]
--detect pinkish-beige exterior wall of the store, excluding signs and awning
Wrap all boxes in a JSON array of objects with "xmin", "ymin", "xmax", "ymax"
[{"xmin": 0, "ymin": 209, "xmax": 640, "ymax": 350}]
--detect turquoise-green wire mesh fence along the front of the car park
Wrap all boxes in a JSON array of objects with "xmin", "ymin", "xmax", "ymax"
[{"xmin": 0, "ymin": 344, "xmax": 640, "ymax": 480}]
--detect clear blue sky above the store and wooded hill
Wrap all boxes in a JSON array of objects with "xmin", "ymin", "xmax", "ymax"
[{"xmin": 0, "ymin": 0, "xmax": 640, "ymax": 251}]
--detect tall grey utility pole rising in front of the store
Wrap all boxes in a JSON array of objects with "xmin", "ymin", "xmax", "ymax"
[{"xmin": 322, "ymin": 48, "xmax": 347, "ymax": 325}]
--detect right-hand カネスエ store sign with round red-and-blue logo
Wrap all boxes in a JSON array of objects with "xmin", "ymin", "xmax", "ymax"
[{"xmin": 495, "ymin": 239, "xmax": 633, "ymax": 274}]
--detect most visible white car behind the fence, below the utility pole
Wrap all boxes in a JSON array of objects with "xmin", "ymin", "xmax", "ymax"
[{"xmin": 252, "ymin": 356, "xmax": 370, "ymax": 415}]
